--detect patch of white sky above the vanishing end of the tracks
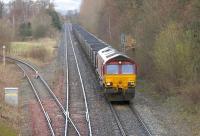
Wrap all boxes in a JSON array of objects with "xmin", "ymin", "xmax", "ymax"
[{"xmin": 2, "ymin": 0, "xmax": 81, "ymax": 13}]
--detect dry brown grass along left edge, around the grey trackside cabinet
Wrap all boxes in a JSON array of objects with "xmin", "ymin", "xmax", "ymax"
[{"xmin": 0, "ymin": 62, "xmax": 21, "ymax": 136}]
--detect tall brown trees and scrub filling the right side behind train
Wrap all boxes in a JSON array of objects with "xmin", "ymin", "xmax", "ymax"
[{"xmin": 79, "ymin": 0, "xmax": 200, "ymax": 135}]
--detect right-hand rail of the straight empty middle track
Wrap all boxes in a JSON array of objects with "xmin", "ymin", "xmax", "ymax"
[{"xmin": 67, "ymin": 23, "xmax": 92, "ymax": 136}]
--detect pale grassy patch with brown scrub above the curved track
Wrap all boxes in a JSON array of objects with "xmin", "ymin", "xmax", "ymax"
[{"xmin": 9, "ymin": 38, "xmax": 57, "ymax": 66}]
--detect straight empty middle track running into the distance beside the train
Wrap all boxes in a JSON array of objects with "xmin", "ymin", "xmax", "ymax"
[{"xmin": 64, "ymin": 24, "xmax": 92, "ymax": 136}]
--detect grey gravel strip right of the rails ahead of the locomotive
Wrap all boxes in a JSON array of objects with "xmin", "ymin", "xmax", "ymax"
[{"xmin": 133, "ymin": 92, "xmax": 177, "ymax": 136}]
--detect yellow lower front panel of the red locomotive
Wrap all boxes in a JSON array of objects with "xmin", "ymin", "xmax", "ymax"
[{"xmin": 103, "ymin": 74, "xmax": 136, "ymax": 90}]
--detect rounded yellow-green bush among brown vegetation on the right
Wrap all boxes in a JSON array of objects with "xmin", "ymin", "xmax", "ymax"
[{"xmin": 154, "ymin": 23, "xmax": 193, "ymax": 85}]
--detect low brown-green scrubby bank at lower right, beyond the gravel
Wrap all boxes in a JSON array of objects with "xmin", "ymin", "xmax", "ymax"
[{"xmin": 137, "ymin": 80, "xmax": 200, "ymax": 136}]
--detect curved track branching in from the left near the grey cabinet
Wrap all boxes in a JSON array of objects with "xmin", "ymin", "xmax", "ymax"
[{"xmin": 6, "ymin": 57, "xmax": 79, "ymax": 136}]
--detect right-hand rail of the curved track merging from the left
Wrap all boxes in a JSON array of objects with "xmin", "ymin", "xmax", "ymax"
[{"xmin": 6, "ymin": 57, "xmax": 80, "ymax": 136}]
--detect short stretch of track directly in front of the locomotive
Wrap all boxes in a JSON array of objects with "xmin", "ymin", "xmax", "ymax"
[{"xmin": 108, "ymin": 102, "xmax": 152, "ymax": 136}]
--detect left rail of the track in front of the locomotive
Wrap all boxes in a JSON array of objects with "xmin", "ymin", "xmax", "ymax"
[{"xmin": 108, "ymin": 102, "xmax": 127, "ymax": 136}]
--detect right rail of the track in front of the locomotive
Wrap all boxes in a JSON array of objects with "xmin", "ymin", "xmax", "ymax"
[{"xmin": 129, "ymin": 106, "xmax": 153, "ymax": 136}]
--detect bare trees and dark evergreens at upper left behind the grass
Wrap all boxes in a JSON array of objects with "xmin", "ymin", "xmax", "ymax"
[{"xmin": 0, "ymin": 0, "xmax": 61, "ymax": 45}]
